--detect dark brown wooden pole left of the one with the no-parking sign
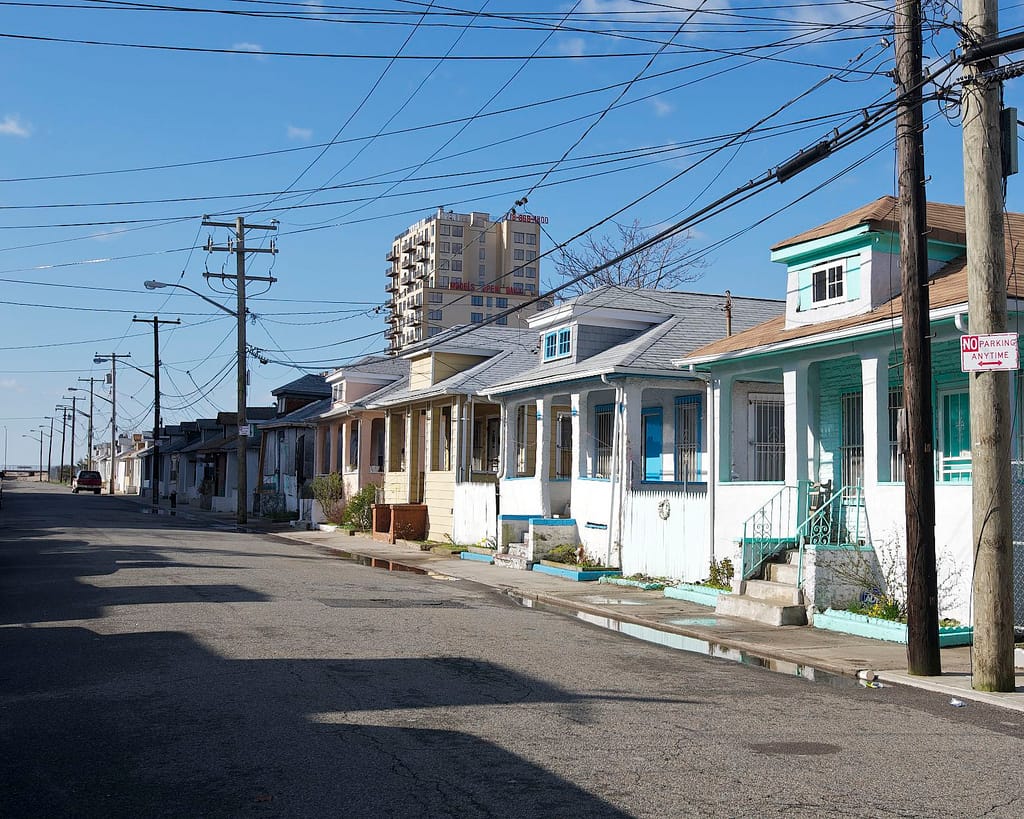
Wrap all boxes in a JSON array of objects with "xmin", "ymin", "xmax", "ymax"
[{"xmin": 895, "ymin": 0, "xmax": 942, "ymax": 677}]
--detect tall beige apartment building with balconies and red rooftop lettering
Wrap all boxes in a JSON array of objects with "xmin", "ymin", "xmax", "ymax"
[{"xmin": 385, "ymin": 208, "xmax": 551, "ymax": 354}]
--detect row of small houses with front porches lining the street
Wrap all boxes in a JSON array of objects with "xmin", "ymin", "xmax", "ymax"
[{"xmin": 99, "ymin": 197, "xmax": 1024, "ymax": 623}]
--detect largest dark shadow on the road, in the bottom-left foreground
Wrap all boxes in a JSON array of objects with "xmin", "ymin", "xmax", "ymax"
[{"xmin": 0, "ymin": 628, "xmax": 627, "ymax": 817}]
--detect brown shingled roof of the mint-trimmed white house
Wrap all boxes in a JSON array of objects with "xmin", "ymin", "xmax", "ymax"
[{"xmin": 676, "ymin": 197, "xmax": 1024, "ymax": 365}]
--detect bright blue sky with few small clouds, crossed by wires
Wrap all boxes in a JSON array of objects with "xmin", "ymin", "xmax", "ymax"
[{"xmin": 0, "ymin": 0, "xmax": 1024, "ymax": 464}]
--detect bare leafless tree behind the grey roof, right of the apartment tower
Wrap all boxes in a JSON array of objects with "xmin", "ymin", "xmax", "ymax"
[{"xmin": 555, "ymin": 219, "xmax": 706, "ymax": 296}]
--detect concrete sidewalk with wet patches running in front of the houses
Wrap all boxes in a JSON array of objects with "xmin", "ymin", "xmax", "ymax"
[{"xmin": 132, "ymin": 495, "xmax": 1024, "ymax": 712}]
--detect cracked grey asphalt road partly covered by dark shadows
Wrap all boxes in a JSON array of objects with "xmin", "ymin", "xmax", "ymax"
[{"xmin": 0, "ymin": 481, "xmax": 1024, "ymax": 817}]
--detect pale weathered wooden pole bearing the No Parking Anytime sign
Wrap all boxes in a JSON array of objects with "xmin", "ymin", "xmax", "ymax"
[{"xmin": 962, "ymin": 0, "xmax": 1014, "ymax": 691}]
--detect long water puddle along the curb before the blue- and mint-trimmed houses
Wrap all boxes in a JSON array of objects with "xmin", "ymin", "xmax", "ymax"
[{"xmin": 506, "ymin": 592, "xmax": 859, "ymax": 688}]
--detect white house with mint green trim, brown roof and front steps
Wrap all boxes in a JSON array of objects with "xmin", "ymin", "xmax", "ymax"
[{"xmin": 675, "ymin": 197, "xmax": 1024, "ymax": 623}]
